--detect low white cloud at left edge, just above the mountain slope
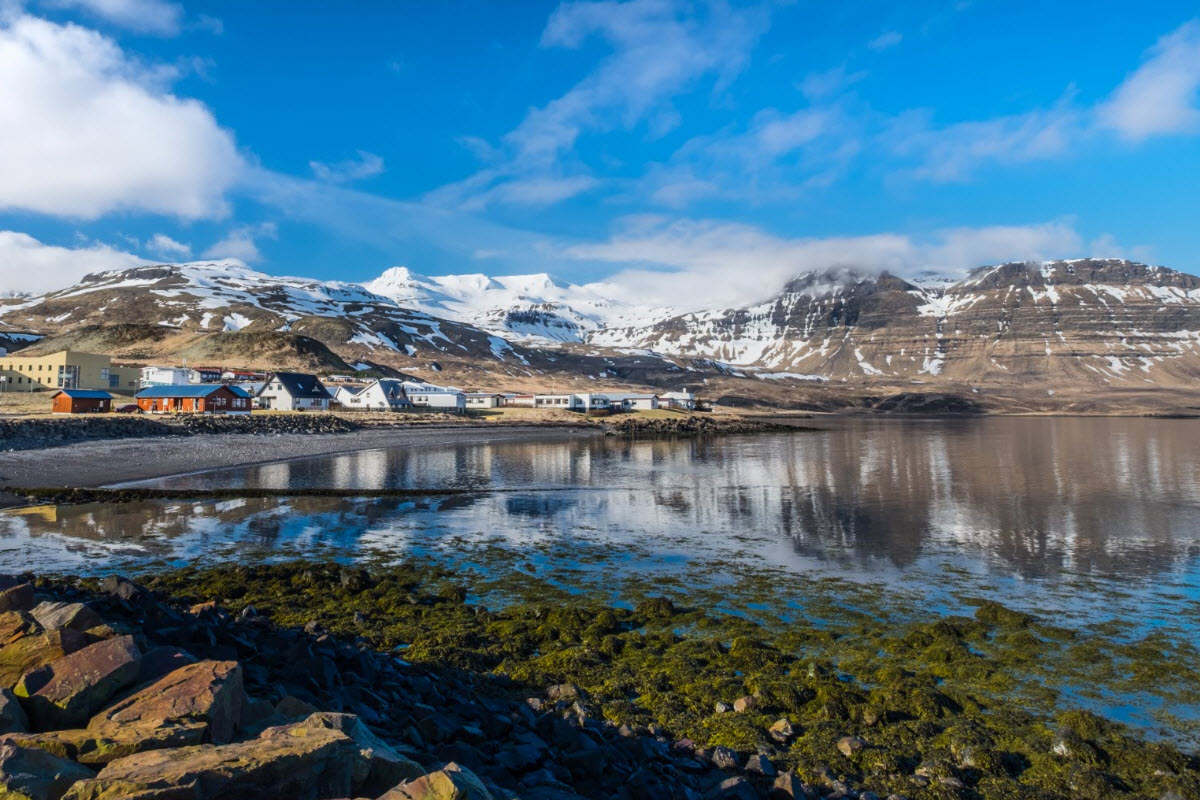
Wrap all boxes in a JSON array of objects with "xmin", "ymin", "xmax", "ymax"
[{"xmin": 0, "ymin": 230, "xmax": 148, "ymax": 293}]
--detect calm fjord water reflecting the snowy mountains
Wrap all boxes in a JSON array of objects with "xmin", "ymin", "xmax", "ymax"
[{"xmin": 0, "ymin": 419, "xmax": 1200, "ymax": 626}]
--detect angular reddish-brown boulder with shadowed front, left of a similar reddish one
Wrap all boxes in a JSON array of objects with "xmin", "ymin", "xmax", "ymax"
[{"xmin": 15, "ymin": 631, "xmax": 142, "ymax": 730}]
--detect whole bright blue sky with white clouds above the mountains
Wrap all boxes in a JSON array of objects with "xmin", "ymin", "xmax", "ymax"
[{"xmin": 0, "ymin": 0, "xmax": 1200, "ymax": 303}]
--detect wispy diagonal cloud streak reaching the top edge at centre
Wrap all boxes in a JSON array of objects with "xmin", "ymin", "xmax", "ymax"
[{"xmin": 430, "ymin": 0, "xmax": 767, "ymax": 207}]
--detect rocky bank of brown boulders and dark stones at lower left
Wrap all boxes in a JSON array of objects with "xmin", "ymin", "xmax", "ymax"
[{"xmin": 0, "ymin": 570, "xmax": 844, "ymax": 800}]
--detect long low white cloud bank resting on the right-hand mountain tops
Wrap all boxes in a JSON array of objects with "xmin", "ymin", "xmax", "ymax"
[{"xmin": 565, "ymin": 217, "xmax": 1082, "ymax": 308}]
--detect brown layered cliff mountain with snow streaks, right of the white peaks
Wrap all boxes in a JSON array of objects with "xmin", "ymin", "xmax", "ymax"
[{"xmin": 592, "ymin": 259, "xmax": 1200, "ymax": 386}]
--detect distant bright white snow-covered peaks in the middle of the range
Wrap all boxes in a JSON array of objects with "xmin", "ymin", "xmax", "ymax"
[{"xmin": 364, "ymin": 266, "xmax": 625, "ymax": 343}]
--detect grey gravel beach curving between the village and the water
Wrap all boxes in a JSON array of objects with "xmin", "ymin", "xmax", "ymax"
[{"xmin": 0, "ymin": 426, "xmax": 601, "ymax": 488}]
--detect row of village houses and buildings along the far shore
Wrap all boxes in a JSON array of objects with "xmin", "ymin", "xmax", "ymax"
[{"xmin": 0, "ymin": 350, "xmax": 697, "ymax": 415}]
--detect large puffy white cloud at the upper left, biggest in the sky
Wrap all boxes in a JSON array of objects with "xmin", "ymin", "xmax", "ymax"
[{"xmin": 0, "ymin": 16, "xmax": 242, "ymax": 219}]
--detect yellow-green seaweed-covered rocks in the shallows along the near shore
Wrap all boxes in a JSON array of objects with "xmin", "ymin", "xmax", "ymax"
[{"xmin": 131, "ymin": 561, "xmax": 1200, "ymax": 800}]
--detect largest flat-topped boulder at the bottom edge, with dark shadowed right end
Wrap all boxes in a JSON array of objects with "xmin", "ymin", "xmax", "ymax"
[{"xmin": 65, "ymin": 722, "xmax": 361, "ymax": 800}]
